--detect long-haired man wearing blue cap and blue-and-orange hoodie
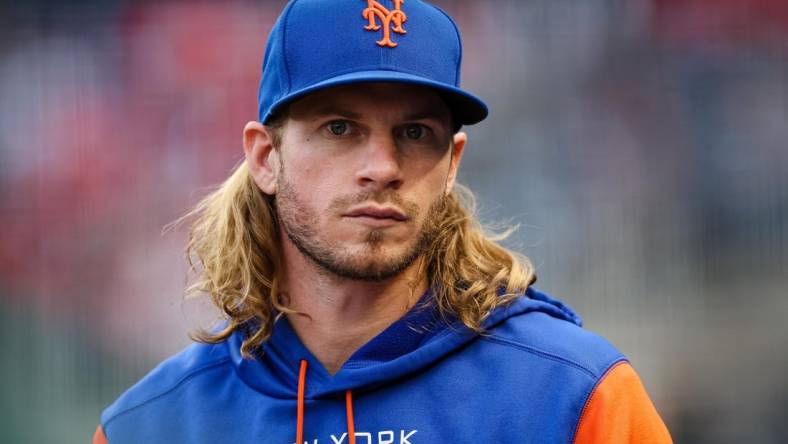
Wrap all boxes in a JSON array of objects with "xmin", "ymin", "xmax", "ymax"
[{"xmin": 94, "ymin": 0, "xmax": 670, "ymax": 444}]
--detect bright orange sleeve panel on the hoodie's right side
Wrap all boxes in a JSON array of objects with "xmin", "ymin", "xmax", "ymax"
[{"xmin": 575, "ymin": 362, "xmax": 673, "ymax": 444}]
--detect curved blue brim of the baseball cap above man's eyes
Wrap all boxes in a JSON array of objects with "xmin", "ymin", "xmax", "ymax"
[{"xmin": 263, "ymin": 70, "xmax": 489, "ymax": 127}]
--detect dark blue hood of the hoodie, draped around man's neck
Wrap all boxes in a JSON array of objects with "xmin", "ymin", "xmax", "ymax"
[{"xmin": 226, "ymin": 288, "xmax": 582, "ymax": 399}]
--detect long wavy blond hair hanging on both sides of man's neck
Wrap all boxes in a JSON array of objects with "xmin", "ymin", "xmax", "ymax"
[{"xmin": 185, "ymin": 158, "xmax": 535, "ymax": 356}]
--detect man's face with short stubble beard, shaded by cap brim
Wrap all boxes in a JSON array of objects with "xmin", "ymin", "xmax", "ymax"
[{"xmin": 275, "ymin": 84, "xmax": 464, "ymax": 281}]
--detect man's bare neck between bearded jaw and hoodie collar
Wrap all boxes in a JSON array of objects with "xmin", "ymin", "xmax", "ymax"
[{"xmin": 284, "ymin": 239, "xmax": 427, "ymax": 374}]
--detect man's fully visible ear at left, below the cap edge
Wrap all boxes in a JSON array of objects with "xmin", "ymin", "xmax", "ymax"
[{"xmin": 244, "ymin": 121, "xmax": 281, "ymax": 195}]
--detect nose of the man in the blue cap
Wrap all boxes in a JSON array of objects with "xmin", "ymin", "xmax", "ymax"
[{"xmin": 356, "ymin": 130, "xmax": 403, "ymax": 191}]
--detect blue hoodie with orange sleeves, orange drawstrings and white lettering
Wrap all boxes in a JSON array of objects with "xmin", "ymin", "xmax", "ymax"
[{"xmin": 93, "ymin": 289, "xmax": 671, "ymax": 444}]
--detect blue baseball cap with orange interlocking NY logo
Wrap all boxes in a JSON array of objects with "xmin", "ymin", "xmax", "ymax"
[{"xmin": 258, "ymin": 0, "xmax": 488, "ymax": 127}]
